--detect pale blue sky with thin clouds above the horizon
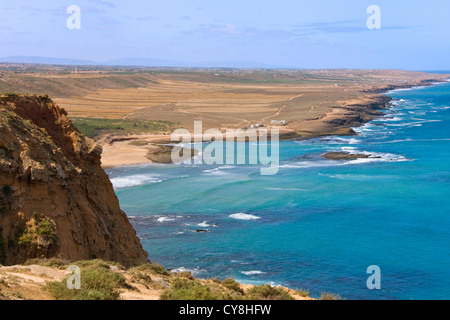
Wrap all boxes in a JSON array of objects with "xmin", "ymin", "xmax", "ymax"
[{"xmin": 0, "ymin": 0, "xmax": 450, "ymax": 70}]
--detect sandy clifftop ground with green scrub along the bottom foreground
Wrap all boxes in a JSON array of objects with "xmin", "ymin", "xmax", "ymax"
[{"xmin": 0, "ymin": 258, "xmax": 310, "ymax": 300}]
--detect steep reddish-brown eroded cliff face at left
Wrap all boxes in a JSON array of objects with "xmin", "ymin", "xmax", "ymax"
[{"xmin": 0, "ymin": 95, "xmax": 147, "ymax": 266}]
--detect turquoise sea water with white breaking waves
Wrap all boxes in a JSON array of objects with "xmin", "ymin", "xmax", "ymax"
[{"xmin": 107, "ymin": 83, "xmax": 450, "ymax": 299}]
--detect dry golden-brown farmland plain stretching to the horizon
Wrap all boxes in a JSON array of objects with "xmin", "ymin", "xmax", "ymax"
[{"xmin": 0, "ymin": 67, "xmax": 445, "ymax": 134}]
